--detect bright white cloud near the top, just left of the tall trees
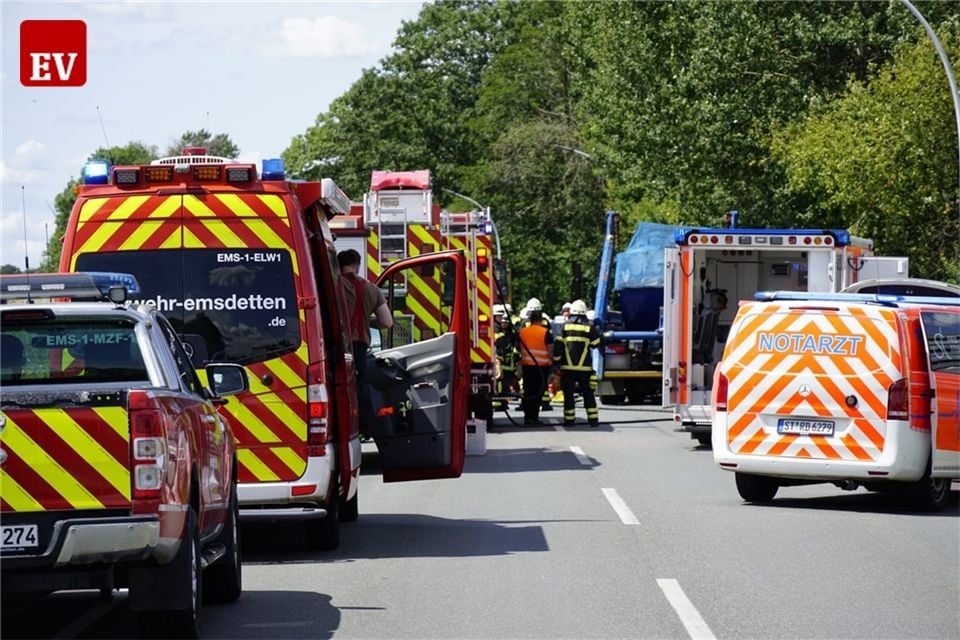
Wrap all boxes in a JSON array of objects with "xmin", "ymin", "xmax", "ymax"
[{"xmin": 260, "ymin": 16, "xmax": 378, "ymax": 58}]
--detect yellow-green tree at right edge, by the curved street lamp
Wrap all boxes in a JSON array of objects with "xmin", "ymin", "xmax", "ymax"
[{"xmin": 771, "ymin": 30, "xmax": 960, "ymax": 282}]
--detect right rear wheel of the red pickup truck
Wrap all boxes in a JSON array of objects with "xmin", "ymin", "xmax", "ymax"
[{"xmin": 137, "ymin": 507, "xmax": 203, "ymax": 638}]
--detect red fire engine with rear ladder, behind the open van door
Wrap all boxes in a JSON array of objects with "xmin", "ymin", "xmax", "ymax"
[{"xmin": 331, "ymin": 170, "xmax": 507, "ymax": 421}]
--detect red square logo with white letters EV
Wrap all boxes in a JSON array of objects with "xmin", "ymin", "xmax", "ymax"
[{"xmin": 20, "ymin": 20, "xmax": 87, "ymax": 87}]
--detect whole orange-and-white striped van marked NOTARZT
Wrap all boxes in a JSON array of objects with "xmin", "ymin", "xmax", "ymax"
[{"xmin": 712, "ymin": 292, "xmax": 960, "ymax": 510}]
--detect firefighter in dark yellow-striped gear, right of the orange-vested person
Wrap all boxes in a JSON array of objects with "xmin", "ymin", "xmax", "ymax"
[{"xmin": 554, "ymin": 300, "xmax": 600, "ymax": 427}]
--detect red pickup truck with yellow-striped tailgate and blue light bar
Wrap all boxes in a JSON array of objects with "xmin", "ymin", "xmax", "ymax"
[{"xmin": 0, "ymin": 274, "xmax": 247, "ymax": 637}]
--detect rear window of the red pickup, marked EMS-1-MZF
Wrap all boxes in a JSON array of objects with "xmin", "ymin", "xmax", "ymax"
[{"xmin": 0, "ymin": 317, "xmax": 149, "ymax": 386}]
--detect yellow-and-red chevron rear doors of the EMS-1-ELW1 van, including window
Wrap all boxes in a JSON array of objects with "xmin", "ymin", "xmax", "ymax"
[{"xmin": 62, "ymin": 189, "xmax": 309, "ymax": 490}]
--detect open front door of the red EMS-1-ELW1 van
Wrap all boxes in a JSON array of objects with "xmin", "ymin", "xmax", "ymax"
[{"xmin": 360, "ymin": 251, "xmax": 470, "ymax": 482}]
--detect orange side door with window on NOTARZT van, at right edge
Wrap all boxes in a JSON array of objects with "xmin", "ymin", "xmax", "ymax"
[{"xmin": 920, "ymin": 308, "xmax": 960, "ymax": 478}]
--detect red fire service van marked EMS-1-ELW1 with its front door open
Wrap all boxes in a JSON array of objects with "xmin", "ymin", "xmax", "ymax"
[{"xmin": 61, "ymin": 148, "xmax": 470, "ymax": 548}]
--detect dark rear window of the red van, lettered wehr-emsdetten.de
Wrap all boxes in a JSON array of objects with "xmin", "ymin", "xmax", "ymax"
[{"xmin": 76, "ymin": 249, "xmax": 300, "ymax": 367}]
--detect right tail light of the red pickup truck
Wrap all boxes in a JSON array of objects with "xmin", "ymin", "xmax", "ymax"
[{"xmin": 127, "ymin": 391, "xmax": 167, "ymax": 500}]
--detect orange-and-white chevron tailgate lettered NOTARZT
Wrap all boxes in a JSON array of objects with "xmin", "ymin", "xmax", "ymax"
[{"xmin": 721, "ymin": 302, "xmax": 906, "ymax": 462}]
